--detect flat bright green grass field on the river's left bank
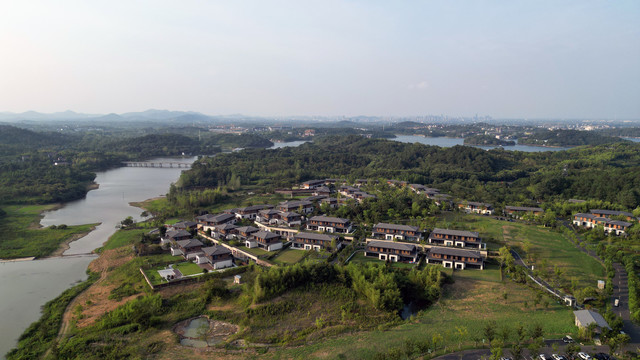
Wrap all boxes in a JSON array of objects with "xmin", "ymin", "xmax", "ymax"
[{"xmin": 0, "ymin": 205, "xmax": 97, "ymax": 259}]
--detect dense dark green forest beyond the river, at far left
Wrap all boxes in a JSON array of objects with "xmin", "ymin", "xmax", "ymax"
[{"xmin": 0, "ymin": 125, "xmax": 273, "ymax": 204}]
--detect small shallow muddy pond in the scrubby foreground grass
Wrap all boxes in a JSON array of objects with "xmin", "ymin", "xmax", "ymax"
[{"xmin": 174, "ymin": 316, "xmax": 238, "ymax": 348}]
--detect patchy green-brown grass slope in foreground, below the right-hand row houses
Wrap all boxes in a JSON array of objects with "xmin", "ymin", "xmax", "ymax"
[{"xmin": 271, "ymin": 269, "xmax": 577, "ymax": 359}]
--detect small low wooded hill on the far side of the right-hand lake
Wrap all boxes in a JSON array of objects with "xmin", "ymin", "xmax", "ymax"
[{"xmin": 518, "ymin": 130, "xmax": 621, "ymax": 146}]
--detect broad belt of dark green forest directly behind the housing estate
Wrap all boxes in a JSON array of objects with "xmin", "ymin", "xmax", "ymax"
[{"xmin": 179, "ymin": 136, "xmax": 640, "ymax": 208}]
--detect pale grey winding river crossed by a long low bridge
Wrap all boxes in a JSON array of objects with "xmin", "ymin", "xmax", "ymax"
[{"xmin": 0, "ymin": 158, "xmax": 196, "ymax": 356}]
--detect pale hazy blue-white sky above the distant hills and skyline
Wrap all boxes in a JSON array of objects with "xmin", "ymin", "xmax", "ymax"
[{"xmin": 0, "ymin": 0, "xmax": 640, "ymax": 119}]
